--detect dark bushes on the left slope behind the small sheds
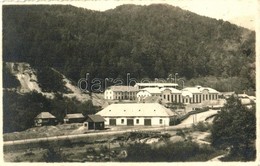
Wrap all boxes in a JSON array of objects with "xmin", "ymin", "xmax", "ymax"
[{"xmin": 3, "ymin": 91, "xmax": 98, "ymax": 133}]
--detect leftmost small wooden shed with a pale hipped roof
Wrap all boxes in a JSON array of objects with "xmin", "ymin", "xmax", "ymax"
[{"xmin": 34, "ymin": 112, "xmax": 58, "ymax": 126}]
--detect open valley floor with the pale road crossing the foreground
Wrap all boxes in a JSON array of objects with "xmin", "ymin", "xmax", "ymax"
[{"xmin": 4, "ymin": 110, "xmax": 223, "ymax": 162}]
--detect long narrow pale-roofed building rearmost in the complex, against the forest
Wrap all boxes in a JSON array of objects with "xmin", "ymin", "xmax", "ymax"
[{"xmin": 135, "ymin": 82, "xmax": 178, "ymax": 89}]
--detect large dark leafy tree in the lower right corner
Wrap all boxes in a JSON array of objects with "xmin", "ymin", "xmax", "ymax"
[{"xmin": 211, "ymin": 96, "xmax": 256, "ymax": 161}]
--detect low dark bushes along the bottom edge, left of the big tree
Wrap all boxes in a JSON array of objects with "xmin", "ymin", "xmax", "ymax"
[{"xmin": 125, "ymin": 141, "xmax": 217, "ymax": 162}]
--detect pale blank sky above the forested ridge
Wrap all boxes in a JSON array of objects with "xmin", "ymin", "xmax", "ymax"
[{"xmin": 70, "ymin": 0, "xmax": 260, "ymax": 30}]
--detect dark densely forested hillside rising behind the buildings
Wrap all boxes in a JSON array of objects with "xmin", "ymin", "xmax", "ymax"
[{"xmin": 3, "ymin": 5, "xmax": 255, "ymax": 91}]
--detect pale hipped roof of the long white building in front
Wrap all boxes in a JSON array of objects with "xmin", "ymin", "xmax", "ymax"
[{"xmin": 97, "ymin": 103, "xmax": 176, "ymax": 117}]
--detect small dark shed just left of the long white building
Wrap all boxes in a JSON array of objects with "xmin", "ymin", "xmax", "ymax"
[{"xmin": 86, "ymin": 115, "xmax": 105, "ymax": 130}]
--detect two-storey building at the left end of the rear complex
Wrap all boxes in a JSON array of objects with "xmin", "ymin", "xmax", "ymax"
[{"xmin": 104, "ymin": 86, "xmax": 138, "ymax": 100}]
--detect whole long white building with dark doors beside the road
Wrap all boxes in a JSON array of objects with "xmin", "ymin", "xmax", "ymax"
[{"xmin": 97, "ymin": 103, "xmax": 177, "ymax": 126}]
